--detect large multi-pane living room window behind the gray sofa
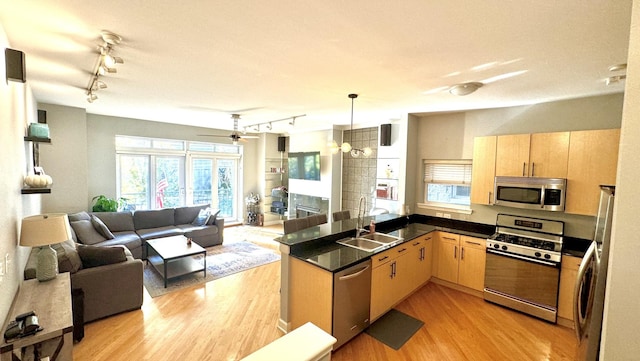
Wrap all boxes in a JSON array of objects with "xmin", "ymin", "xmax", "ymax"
[{"xmin": 116, "ymin": 136, "xmax": 241, "ymax": 220}]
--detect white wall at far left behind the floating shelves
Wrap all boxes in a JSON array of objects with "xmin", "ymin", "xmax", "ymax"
[{"xmin": 0, "ymin": 26, "xmax": 41, "ymax": 322}]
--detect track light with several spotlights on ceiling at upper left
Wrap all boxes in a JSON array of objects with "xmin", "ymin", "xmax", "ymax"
[{"xmin": 87, "ymin": 30, "xmax": 124, "ymax": 103}]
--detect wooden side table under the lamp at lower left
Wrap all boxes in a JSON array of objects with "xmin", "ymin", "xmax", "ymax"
[{"xmin": 0, "ymin": 273, "xmax": 73, "ymax": 361}]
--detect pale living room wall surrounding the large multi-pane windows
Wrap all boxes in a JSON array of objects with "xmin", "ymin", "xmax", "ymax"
[{"xmin": 33, "ymin": 108, "xmax": 264, "ymax": 215}]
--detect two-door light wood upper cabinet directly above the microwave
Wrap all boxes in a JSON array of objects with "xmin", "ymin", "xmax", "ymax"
[{"xmin": 495, "ymin": 132, "xmax": 570, "ymax": 178}]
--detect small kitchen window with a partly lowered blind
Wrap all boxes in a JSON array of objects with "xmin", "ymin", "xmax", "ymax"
[{"xmin": 424, "ymin": 160, "xmax": 471, "ymax": 210}]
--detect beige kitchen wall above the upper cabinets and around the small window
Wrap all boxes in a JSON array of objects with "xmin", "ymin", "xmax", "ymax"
[{"xmin": 407, "ymin": 93, "xmax": 624, "ymax": 239}]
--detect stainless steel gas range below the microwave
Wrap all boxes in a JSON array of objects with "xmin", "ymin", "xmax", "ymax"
[{"xmin": 484, "ymin": 214, "xmax": 564, "ymax": 323}]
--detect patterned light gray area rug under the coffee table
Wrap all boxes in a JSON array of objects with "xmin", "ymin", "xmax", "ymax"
[{"xmin": 144, "ymin": 241, "xmax": 280, "ymax": 297}]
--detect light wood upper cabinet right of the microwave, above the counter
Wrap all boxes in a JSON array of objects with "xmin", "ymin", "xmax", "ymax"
[{"xmin": 565, "ymin": 129, "xmax": 620, "ymax": 215}]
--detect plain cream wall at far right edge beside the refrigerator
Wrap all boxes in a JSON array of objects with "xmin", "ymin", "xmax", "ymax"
[{"xmin": 600, "ymin": 1, "xmax": 640, "ymax": 361}]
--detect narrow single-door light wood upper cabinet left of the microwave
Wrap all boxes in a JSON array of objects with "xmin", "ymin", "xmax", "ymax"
[{"xmin": 471, "ymin": 136, "xmax": 497, "ymax": 204}]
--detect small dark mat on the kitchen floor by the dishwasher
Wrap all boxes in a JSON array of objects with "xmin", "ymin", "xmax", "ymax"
[{"xmin": 364, "ymin": 309, "xmax": 424, "ymax": 350}]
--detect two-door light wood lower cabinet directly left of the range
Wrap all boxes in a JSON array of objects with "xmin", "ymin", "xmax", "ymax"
[{"xmin": 434, "ymin": 232, "xmax": 486, "ymax": 291}]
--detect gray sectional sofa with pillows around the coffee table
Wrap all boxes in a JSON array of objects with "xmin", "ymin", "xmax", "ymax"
[{"xmin": 24, "ymin": 205, "xmax": 224, "ymax": 322}]
